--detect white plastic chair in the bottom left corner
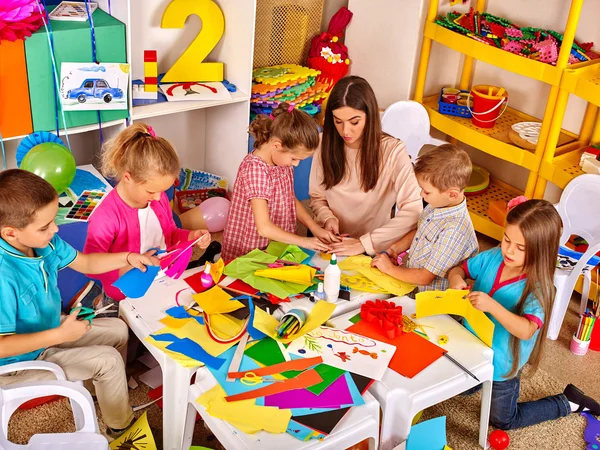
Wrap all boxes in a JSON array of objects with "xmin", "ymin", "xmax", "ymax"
[{"xmin": 0, "ymin": 361, "xmax": 108, "ymax": 450}]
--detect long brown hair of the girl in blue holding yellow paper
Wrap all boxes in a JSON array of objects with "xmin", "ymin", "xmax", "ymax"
[{"xmin": 505, "ymin": 200, "xmax": 562, "ymax": 378}]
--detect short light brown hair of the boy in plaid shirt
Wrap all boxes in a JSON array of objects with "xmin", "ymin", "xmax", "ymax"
[{"xmin": 415, "ymin": 144, "xmax": 473, "ymax": 192}]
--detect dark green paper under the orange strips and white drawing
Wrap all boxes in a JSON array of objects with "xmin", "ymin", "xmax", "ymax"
[{"xmin": 244, "ymin": 337, "xmax": 346, "ymax": 395}]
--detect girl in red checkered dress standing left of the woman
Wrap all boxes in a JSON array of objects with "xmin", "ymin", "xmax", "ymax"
[{"xmin": 221, "ymin": 103, "xmax": 335, "ymax": 262}]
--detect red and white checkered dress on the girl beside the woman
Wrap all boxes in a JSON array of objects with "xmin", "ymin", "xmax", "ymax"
[{"xmin": 221, "ymin": 153, "xmax": 296, "ymax": 262}]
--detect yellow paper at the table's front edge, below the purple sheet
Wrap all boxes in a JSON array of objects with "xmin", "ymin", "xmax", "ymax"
[{"xmin": 196, "ymin": 384, "xmax": 292, "ymax": 434}]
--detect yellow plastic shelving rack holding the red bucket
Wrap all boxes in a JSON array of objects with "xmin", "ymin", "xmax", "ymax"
[{"xmin": 414, "ymin": 0, "xmax": 596, "ymax": 240}]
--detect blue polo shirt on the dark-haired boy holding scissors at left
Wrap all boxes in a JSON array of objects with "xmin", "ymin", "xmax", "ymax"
[{"xmin": 0, "ymin": 235, "xmax": 77, "ymax": 366}]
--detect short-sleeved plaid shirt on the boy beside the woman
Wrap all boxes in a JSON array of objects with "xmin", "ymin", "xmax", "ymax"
[{"xmin": 406, "ymin": 199, "xmax": 479, "ymax": 292}]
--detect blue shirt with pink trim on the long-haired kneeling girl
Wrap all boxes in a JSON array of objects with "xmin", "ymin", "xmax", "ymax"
[{"xmin": 463, "ymin": 247, "xmax": 544, "ymax": 381}]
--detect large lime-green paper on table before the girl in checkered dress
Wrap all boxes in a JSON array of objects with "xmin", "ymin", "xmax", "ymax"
[{"xmin": 223, "ymin": 249, "xmax": 306, "ymax": 298}]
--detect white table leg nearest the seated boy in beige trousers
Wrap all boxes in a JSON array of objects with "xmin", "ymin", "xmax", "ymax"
[{"xmin": 162, "ymin": 358, "xmax": 191, "ymax": 450}]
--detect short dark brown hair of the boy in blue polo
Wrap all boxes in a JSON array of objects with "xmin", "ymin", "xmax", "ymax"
[{"xmin": 0, "ymin": 169, "xmax": 58, "ymax": 230}]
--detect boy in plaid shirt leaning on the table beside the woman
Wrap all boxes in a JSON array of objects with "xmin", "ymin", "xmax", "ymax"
[{"xmin": 371, "ymin": 144, "xmax": 479, "ymax": 292}]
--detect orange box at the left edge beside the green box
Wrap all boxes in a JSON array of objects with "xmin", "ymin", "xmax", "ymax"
[{"xmin": 0, "ymin": 41, "xmax": 33, "ymax": 138}]
